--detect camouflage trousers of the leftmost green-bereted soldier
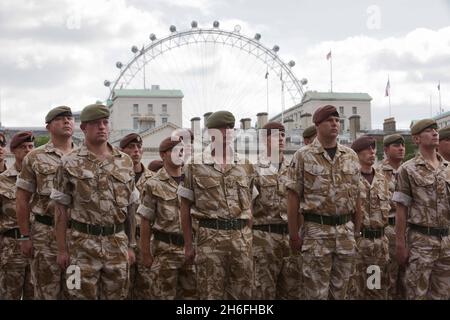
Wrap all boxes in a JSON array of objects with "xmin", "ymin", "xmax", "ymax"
[{"xmin": 31, "ymin": 222, "xmax": 65, "ymax": 300}]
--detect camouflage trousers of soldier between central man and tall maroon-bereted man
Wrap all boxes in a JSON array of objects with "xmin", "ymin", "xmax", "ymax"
[{"xmin": 252, "ymin": 230, "xmax": 303, "ymax": 300}]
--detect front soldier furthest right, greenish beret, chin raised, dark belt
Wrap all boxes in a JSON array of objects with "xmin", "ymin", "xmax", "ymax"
[{"xmin": 393, "ymin": 119, "xmax": 450, "ymax": 300}]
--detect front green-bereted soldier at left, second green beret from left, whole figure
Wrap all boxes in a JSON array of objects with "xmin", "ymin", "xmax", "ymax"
[{"xmin": 51, "ymin": 104, "xmax": 139, "ymax": 299}]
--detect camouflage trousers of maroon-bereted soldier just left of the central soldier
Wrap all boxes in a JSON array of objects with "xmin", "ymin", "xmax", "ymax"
[{"xmin": 149, "ymin": 240, "xmax": 197, "ymax": 300}]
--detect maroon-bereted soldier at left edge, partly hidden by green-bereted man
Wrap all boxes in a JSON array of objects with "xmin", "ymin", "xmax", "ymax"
[{"xmin": 0, "ymin": 131, "xmax": 34, "ymax": 300}]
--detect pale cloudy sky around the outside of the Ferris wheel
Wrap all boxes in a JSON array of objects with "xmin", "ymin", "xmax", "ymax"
[{"xmin": 0, "ymin": 0, "xmax": 450, "ymax": 128}]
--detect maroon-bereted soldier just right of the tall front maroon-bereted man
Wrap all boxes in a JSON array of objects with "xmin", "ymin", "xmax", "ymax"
[{"xmin": 349, "ymin": 136, "xmax": 391, "ymax": 300}]
